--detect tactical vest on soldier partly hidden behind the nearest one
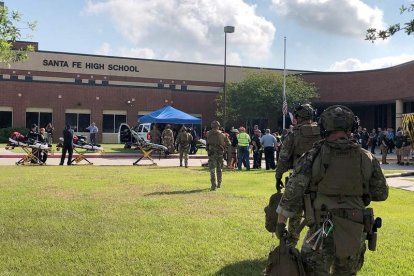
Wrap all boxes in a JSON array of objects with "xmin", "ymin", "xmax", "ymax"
[{"xmin": 293, "ymin": 123, "xmax": 321, "ymax": 167}]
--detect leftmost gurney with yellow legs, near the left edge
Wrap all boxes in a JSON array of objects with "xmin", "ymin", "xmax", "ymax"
[{"xmin": 6, "ymin": 135, "xmax": 52, "ymax": 165}]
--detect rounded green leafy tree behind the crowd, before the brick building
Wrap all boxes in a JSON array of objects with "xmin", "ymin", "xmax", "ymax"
[{"xmin": 217, "ymin": 72, "xmax": 318, "ymax": 129}]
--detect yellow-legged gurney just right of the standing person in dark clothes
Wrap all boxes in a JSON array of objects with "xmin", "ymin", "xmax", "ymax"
[{"xmin": 56, "ymin": 135, "xmax": 103, "ymax": 165}]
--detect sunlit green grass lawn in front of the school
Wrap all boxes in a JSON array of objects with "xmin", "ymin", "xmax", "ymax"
[{"xmin": 0, "ymin": 166, "xmax": 414, "ymax": 275}]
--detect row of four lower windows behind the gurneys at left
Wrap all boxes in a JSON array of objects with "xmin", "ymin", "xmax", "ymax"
[{"xmin": 0, "ymin": 111, "xmax": 126, "ymax": 133}]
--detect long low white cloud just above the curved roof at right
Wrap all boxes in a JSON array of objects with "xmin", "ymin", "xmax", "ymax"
[{"xmin": 328, "ymin": 54, "xmax": 414, "ymax": 72}]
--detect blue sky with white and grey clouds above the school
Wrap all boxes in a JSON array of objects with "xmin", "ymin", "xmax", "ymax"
[{"xmin": 2, "ymin": 0, "xmax": 414, "ymax": 72}]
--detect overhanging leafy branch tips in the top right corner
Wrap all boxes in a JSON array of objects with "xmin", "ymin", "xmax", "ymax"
[{"xmin": 365, "ymin": 4, "xmax": 414, "ymax": 43}]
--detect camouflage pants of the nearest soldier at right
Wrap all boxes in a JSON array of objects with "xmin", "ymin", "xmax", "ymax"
[{"xmin": 301, "ymin": 229, "xmax": 366, "ymax": 276}]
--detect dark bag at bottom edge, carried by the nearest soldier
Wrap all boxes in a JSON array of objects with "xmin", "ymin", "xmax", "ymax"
[{"xmin": 264, "ymin": 239, "xmax": 305, "ymax": 276}]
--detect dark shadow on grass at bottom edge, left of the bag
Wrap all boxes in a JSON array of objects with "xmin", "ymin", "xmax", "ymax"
[{"xmin": 215, "ymin": 260, "xmax": 266, "ymax": 276}]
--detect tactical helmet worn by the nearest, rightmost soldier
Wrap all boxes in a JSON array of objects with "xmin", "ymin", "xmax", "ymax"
[{"xmin": 319, "ymin": 105, "xmax": 359, "ymax": 132}]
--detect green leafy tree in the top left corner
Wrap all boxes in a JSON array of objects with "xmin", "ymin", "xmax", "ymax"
[{"xmin": 0, "ymin": 3, "xmax": 36, "ymax": 64}]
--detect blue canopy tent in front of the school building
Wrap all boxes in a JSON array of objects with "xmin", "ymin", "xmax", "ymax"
[{"xmin": 138, "ymin": 106, "xmax": 201, "ymax": 125}]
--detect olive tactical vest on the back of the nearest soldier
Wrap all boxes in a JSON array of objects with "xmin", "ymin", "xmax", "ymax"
[{"xmin": 310, "ymin": 143, "xmax": 372, "ymax": 197}]
